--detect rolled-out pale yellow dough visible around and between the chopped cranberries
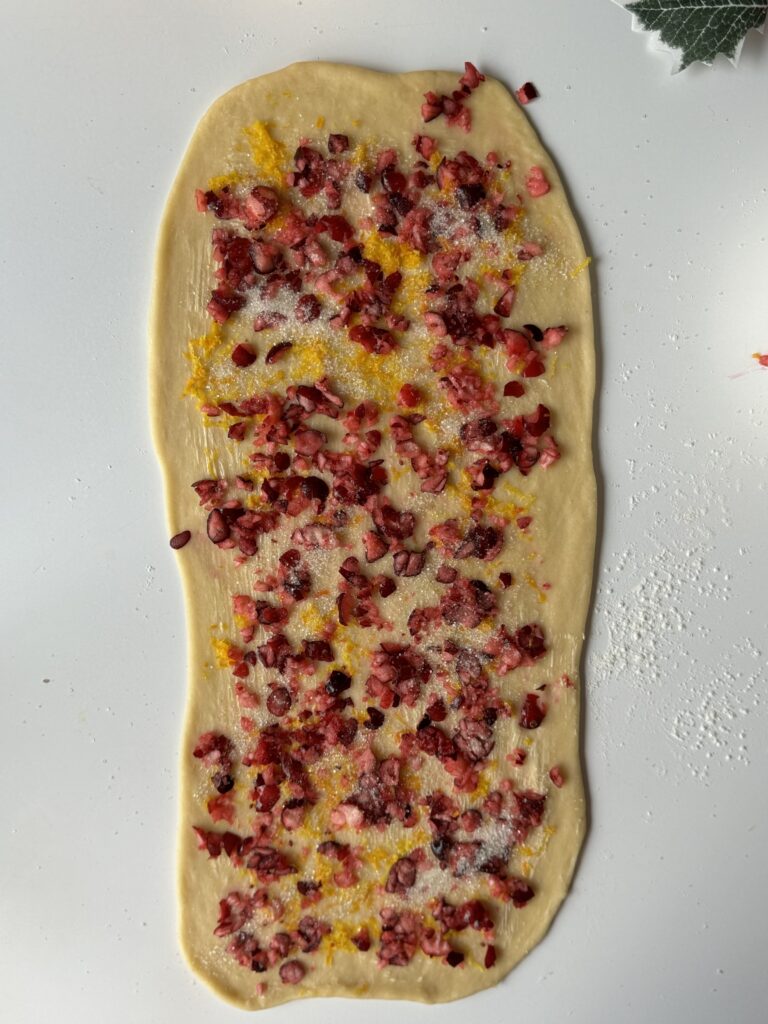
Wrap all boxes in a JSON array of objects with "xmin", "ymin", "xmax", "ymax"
[{"xmin": 151, "ymin": 62, "xmax": 596, "ymax": 1010}]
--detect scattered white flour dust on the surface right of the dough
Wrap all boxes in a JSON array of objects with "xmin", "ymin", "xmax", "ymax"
[{"xmin": 586, "ymin": 461, "xmax": 766, "ymax": 783}]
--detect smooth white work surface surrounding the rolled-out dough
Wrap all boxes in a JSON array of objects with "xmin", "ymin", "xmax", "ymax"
[{"xmin": 0, "ymin": 0, "xmax": 768, "ymax": 1024}]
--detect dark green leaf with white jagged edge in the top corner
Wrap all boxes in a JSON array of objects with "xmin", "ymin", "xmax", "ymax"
[{"xmin": 615, "ymin": 0, "xmax": 768, "ymax": 71}]
